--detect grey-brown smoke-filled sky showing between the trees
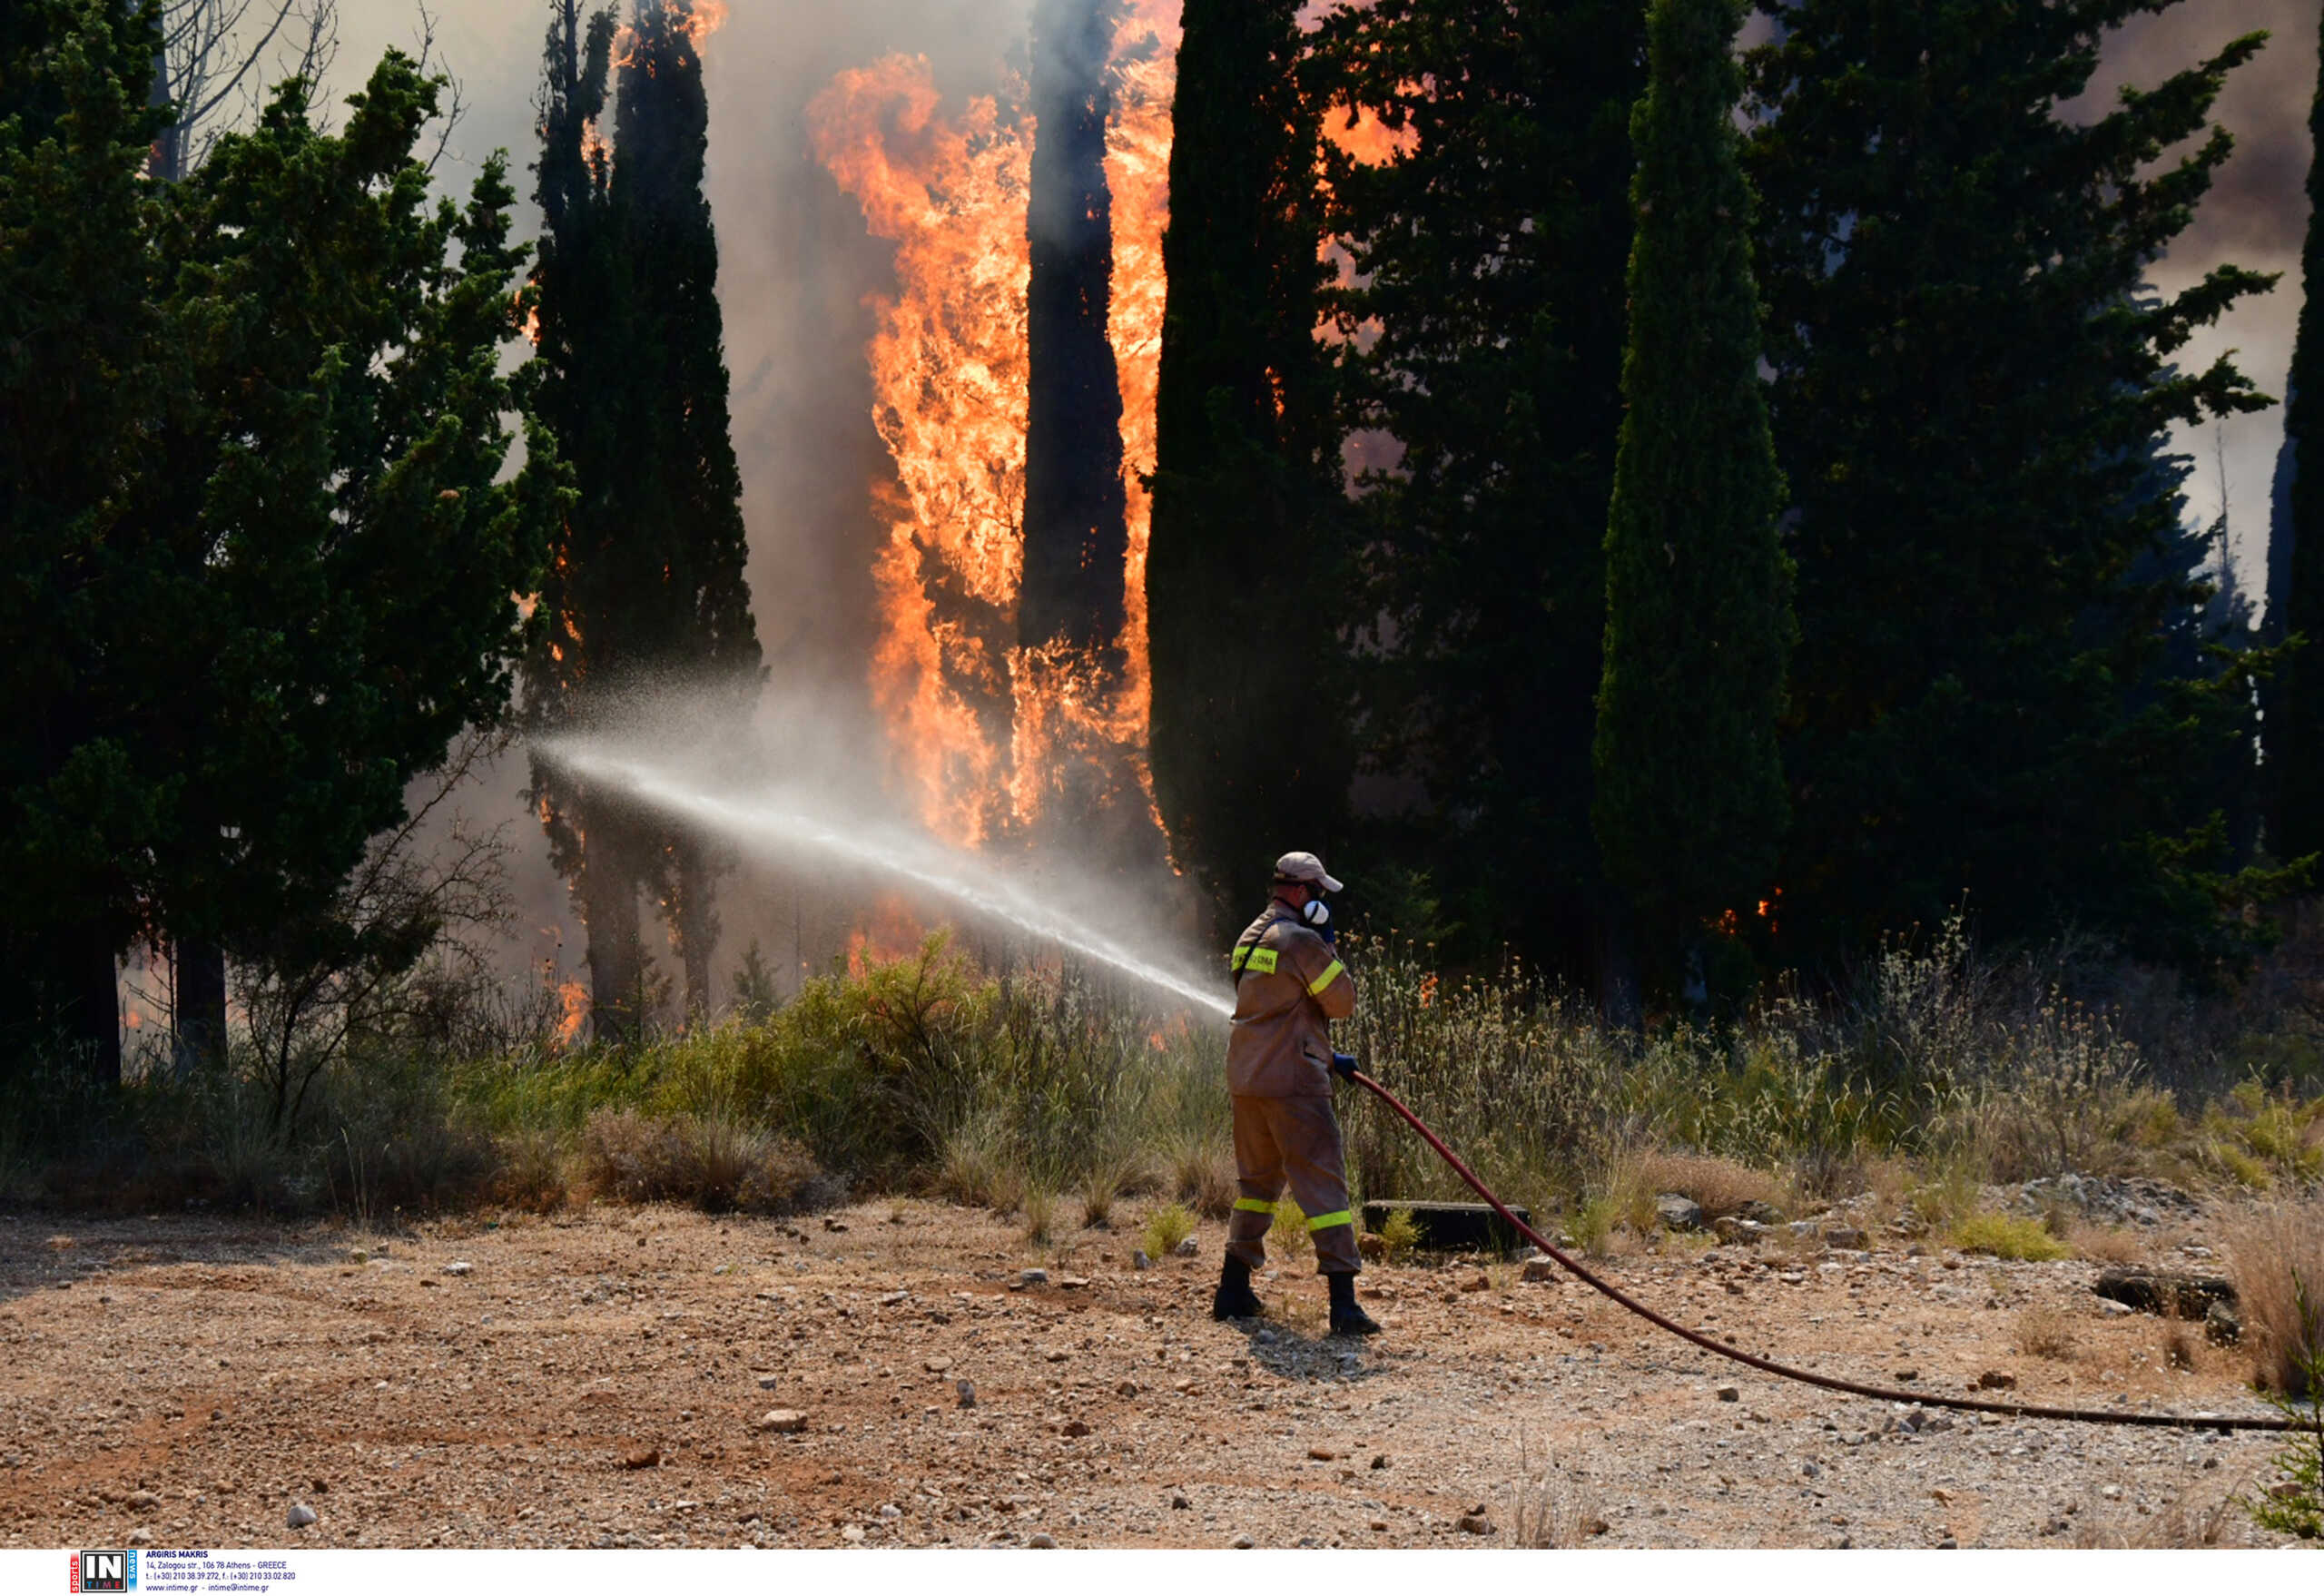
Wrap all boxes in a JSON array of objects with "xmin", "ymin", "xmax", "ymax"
[{"xmin": 335, "ymin": 0, "xmax": 2319, "ymax": 617}]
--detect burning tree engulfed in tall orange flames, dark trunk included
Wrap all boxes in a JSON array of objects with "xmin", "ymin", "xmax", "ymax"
[{"xmin": 809, "ymin": 0, "xmax": 1174, "ymax": 860}]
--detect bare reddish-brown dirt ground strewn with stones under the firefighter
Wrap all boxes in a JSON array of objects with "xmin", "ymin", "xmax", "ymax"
[{"xmin": 0, "ymin": 1201, "xmax": 2275, "ymax": 1547}]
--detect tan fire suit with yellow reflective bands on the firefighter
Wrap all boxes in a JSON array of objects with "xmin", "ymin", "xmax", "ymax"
[{"xmin": 1227, "ymin": 899, "xmax": 1360, "ymax": 1276}]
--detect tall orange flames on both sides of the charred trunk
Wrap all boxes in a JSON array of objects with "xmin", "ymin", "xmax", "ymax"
[{"xmin": 809, "ymin": 0, "xmax": 1178, "ymax": 845}]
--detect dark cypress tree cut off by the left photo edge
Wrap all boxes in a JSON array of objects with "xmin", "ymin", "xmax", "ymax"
[{"xmin": 0, "ymin": 0, "xmax": 170, "ymax": 1080}]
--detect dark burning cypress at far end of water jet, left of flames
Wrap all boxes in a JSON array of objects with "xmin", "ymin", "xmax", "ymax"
[{"xmin": 526, "ymin": 0, "xmax": 763, "ymax": 1036}]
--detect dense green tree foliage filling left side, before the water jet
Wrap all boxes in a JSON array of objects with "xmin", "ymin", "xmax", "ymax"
[{"xmin": 0, "ymin": 5, "xmax": 560, "ymax": 1073}]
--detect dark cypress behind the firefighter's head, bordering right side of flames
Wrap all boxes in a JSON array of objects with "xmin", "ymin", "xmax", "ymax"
[{"xmin": 1146, "ymin": 0, "xmax": 1348, "ymax": 927}]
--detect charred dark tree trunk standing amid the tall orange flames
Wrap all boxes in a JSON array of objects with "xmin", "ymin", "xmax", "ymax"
[{"xmin": 1018, "ymin": 0, "xmax": 1129, "ymax": 669}]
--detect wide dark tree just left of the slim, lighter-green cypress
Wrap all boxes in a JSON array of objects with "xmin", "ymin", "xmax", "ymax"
[{"xmin": 1320, "ymin": 0, "xmax": 1645, "ymax": 980}]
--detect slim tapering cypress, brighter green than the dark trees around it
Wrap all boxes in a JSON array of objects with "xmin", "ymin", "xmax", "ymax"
[{"xmin": 1594, "ymin": 0, "xmax": 1792, "ymax": 994}]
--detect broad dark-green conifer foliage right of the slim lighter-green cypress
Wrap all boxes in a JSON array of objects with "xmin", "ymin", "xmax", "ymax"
[{"xmin": 1748, "ymin": 0, "xmax": 2282, "ymax": 964}]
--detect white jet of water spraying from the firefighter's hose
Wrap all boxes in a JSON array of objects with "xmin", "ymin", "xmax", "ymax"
[{"xmin": 541, "ymin": 741, "xmax": 1234, "ymax": 1020}]
